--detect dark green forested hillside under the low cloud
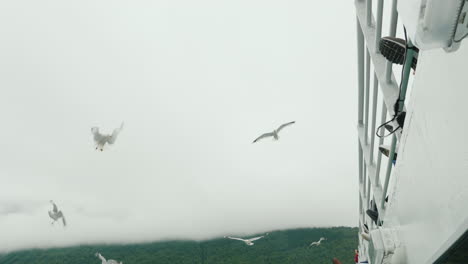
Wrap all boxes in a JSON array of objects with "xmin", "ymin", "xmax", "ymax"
[{"xmin": 0, "ymin": 227, "xmax": 358, "ymax": 264}]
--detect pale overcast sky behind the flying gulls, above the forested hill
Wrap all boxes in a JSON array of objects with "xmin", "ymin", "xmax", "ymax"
[{"xmin": 0, "ymin": 0, "xmax": 358, "ymax": 251}]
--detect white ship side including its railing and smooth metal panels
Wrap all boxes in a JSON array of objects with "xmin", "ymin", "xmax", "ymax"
[{"xmin": 355, "ymin": 0, "xmax": 468, "ymax": 264}]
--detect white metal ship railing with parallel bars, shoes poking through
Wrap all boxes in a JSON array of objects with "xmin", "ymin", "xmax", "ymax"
[{"xmin": 355, "ymin": 0, "xmax": 413, "ymax": 253}]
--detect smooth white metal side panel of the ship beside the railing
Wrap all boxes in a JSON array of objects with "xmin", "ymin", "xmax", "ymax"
[{"xmin": 384, "ymin": 41, "xmax": 468, "ymax": 263}]
